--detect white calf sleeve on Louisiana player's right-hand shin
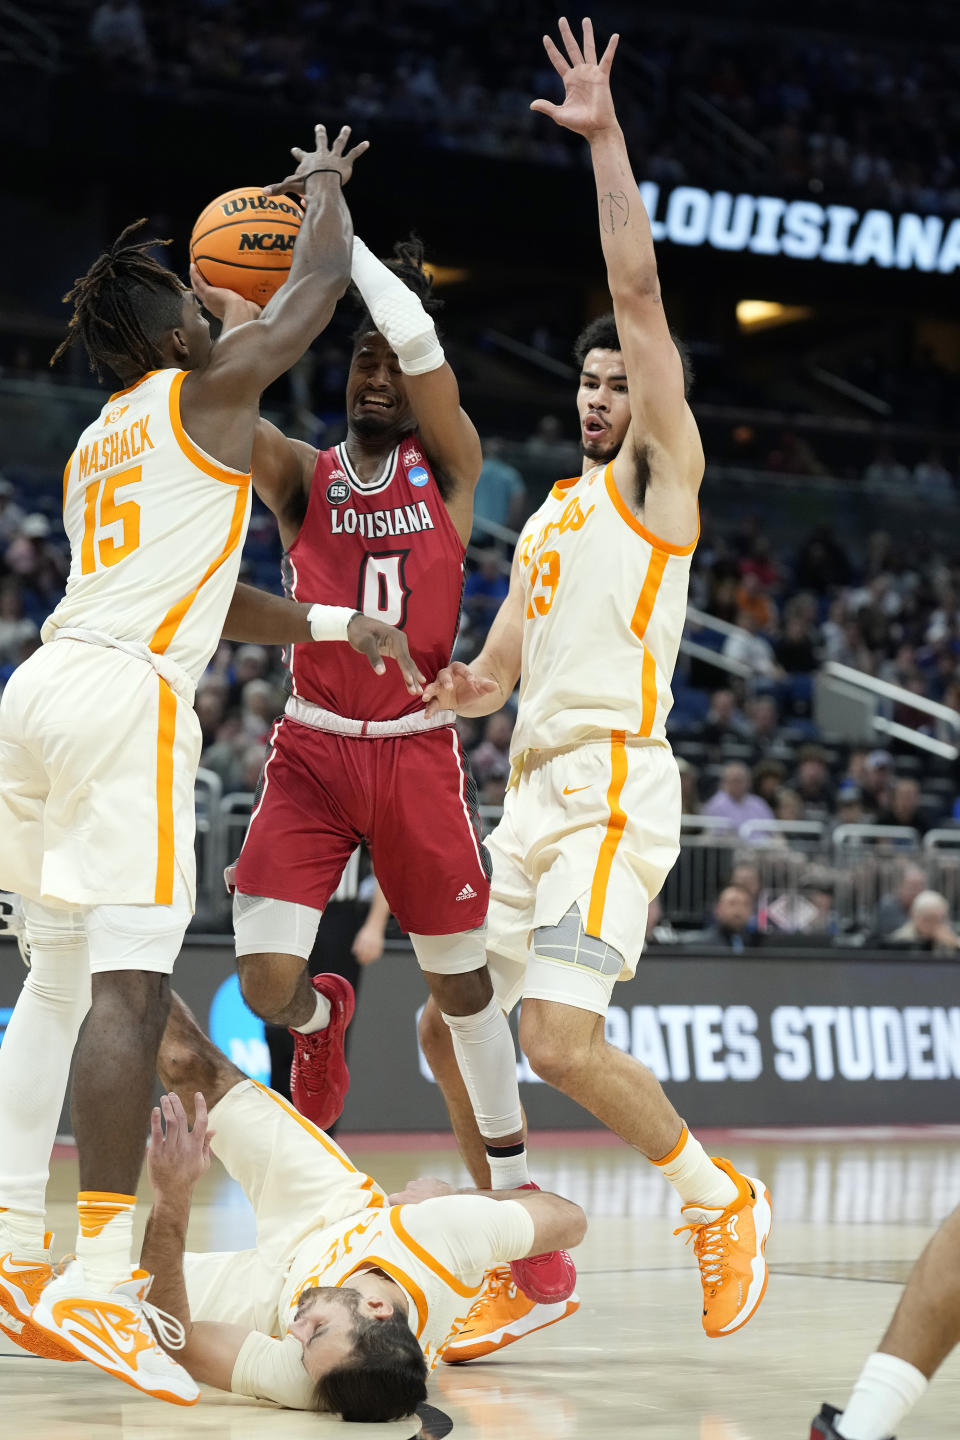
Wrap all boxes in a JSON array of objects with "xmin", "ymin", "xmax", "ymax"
[{"xmin": 440, "ymin": 998, "xmax": 524, "ymax": 1146}]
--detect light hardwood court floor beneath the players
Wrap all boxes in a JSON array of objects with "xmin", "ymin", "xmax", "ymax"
[{"xmin": 0, "ymin": 1128, "xmax": 960, "ymax": 1440}]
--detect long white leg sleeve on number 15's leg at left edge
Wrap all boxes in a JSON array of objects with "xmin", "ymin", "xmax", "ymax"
[{"xmin": 0, "ymin": 901, "xmax": 91, "ymax": 1226}]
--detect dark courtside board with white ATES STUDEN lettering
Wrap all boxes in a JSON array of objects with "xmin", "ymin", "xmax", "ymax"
[{"xmin": 0, "ymin": 942, "xmax": 960, "ymax": 1132}]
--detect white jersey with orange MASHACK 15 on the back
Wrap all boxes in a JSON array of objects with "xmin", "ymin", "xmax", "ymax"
[{"xmin": 42, "ymin": 370, "xmax": 250, "ymax": 684}]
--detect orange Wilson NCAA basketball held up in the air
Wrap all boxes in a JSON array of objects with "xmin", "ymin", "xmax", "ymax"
[{"xmin": 190, "ymin": 186, "xmax": 304, "ymax": 305}]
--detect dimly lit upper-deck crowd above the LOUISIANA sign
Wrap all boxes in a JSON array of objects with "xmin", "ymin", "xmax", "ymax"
[{"xmin": 71, "ymin": 0, "xmax": 960, "ymax": 215}]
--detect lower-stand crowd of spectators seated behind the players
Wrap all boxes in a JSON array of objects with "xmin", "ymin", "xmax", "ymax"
[{"xmin": 0, "ymin": 414, "xmax": 960, "ymax": 948}]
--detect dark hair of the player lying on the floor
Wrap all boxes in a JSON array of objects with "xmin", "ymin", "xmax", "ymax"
[{"xmin": 314, "ymin": 1310, "xmax": 426, "ymax": 1421}]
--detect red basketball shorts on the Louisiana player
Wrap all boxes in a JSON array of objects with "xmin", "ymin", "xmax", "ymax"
[{"xmin": 236, "ymin": 716, "xmax": 491, "ymax": 935}]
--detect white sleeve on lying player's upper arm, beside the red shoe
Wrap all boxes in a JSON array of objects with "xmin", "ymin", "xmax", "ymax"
[{"xmin": 400, "ymin": 1195, "xmax": 534, "ymax": 1284}]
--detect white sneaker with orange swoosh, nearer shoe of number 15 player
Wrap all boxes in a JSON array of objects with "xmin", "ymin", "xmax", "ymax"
[{"xmin": 30, "ymin": 1260, "xmax": 200, "ymax": 1405}]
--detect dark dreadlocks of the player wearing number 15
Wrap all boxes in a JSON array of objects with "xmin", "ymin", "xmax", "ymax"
[{"xmin": 50, "ymin": 219, "xmax": 184, "ymax": 380}]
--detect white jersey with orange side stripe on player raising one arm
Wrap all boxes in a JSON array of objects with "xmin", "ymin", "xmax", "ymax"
[{"xmin": 511, "ymin": 465, "xmax": 697, "ymax": 757}]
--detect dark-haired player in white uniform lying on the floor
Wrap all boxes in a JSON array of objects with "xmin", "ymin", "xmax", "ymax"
[{"xmin": 141, "ymin": 995, "xmax": 586, "ymax": 1420}]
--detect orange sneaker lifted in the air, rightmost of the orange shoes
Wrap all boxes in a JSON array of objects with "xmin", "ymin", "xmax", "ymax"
[{"xmin": 674, "ymin": 1156, "xmax": 773, "ymax": 1339}]
